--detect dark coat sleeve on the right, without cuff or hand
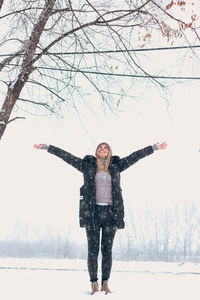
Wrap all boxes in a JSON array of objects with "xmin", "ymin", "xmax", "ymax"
[{"xmin": 119, "ymin": 146, "xmax": 154, "ymax": 172}]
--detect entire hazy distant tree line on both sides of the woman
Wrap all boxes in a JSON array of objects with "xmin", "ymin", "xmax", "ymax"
[{"xmin": 0, "ymin": 203, "xmax": 200, "ymax": 262}]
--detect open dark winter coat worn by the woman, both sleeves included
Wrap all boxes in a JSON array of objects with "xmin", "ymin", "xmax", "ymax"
[{"xmin": 48, "ymin": 145, "xmax": 154, "ymax": 229}]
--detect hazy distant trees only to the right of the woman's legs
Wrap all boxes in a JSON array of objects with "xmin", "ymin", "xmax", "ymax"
[{"xmin": 115, "ymin": 203, "xmax": 200, "ymax": 262}]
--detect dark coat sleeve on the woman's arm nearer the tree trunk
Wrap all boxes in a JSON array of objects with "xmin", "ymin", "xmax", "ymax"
[{"xmin": 48, "ymin": 145, "xmax": 83, "ymax": 172}]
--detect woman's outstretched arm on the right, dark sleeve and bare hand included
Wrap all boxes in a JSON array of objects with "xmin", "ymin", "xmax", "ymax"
[{"xmin": 119, "ymin": 142, "xmax": 167, "ymax": 172}]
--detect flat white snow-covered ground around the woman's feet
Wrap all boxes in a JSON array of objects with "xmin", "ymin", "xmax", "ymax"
[{"xmin": 0, "ymin": 258, "xmax": 200, "ymax": 300}]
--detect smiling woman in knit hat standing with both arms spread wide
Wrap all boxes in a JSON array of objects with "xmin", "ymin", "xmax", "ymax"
[{"xmin": 34, "ymin": 142, "xmax": 167, "ymax": 295}]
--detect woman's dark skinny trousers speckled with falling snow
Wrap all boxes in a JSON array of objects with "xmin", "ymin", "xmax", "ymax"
[{"xmin": 86, "ymin": 205, "xmax": 116, "ymax": 282}]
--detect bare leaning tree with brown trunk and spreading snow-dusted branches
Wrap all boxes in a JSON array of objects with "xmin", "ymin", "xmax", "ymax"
[{"xmin": 0, "ymin": 0, "xmax": 200, "ymax": 139}]
